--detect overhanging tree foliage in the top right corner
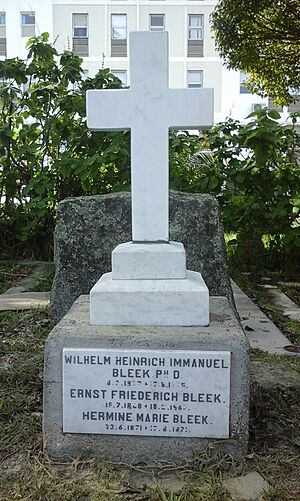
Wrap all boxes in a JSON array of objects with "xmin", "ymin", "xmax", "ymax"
[{"xmin": 211, "ymin": 0, "xmax": 300, "ymax": 105}]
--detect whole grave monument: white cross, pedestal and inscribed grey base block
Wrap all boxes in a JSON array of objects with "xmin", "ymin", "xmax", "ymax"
[{"xmin": 44, "ymin": 32, "xmax": 249, "ymax": 463}]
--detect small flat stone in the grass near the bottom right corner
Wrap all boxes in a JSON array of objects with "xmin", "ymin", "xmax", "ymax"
[{"xmin": 223, "ymin": 471, "xmax": 270, "ymax": 501}]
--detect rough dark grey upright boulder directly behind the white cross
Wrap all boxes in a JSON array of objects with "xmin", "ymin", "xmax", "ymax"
[{"xmin": 51, "ymin": 192, "xmax": 233, "ymax": 321}]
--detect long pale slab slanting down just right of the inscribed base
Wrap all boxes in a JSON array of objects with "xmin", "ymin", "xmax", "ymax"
[{"xmin": 231, "ymin": 280, "xmax": 291, "ymax": 355}]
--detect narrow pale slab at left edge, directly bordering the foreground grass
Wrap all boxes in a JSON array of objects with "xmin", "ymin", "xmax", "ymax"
[{"xmin": 0, "ymin": 292, "xmax": 50, "ymax": 311}]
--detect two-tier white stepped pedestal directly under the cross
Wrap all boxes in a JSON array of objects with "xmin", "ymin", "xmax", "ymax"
[{"xmin": 90, "ymin": 242, "xmax": 209, "ymax": 326}]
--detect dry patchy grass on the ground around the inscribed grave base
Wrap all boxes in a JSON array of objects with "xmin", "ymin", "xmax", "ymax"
[{"xmin": 0, "ymin": 310, "xmax": 300, "ymax": 501}]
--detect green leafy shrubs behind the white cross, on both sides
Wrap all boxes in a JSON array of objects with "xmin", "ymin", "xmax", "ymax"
[{"xmin": 0, "ymin": 34, "xmax": 300, "ymax": 268}]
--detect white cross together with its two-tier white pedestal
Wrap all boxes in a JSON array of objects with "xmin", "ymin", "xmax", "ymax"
[{"xmin": 87, "ymin": 32, "xmax": 213, "ymax": 325}]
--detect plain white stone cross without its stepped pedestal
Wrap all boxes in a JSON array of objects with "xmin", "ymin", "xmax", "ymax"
[{"xmin": 87, "ymin": 32, "xmax": 213, "ymax": 242}]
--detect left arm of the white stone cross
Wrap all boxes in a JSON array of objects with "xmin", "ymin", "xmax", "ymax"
[{"xmin": 87, "ymin": 89, "xmax": 132, "ymax": 131}]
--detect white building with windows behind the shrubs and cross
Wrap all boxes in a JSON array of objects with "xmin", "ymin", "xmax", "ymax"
[{"xmin": 0, "ymin": 0, "xmax": 274, "ymax": 122}]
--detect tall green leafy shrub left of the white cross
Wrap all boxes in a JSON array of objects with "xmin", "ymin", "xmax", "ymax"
[{"xmin": 0, "ymin": 34, "xmax": 130, "ymax": 257}]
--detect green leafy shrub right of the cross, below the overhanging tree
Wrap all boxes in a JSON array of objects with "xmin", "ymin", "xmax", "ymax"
[{"xmin": 192, "ymin": 109, "xmax": 300, "ymax": 265}]
